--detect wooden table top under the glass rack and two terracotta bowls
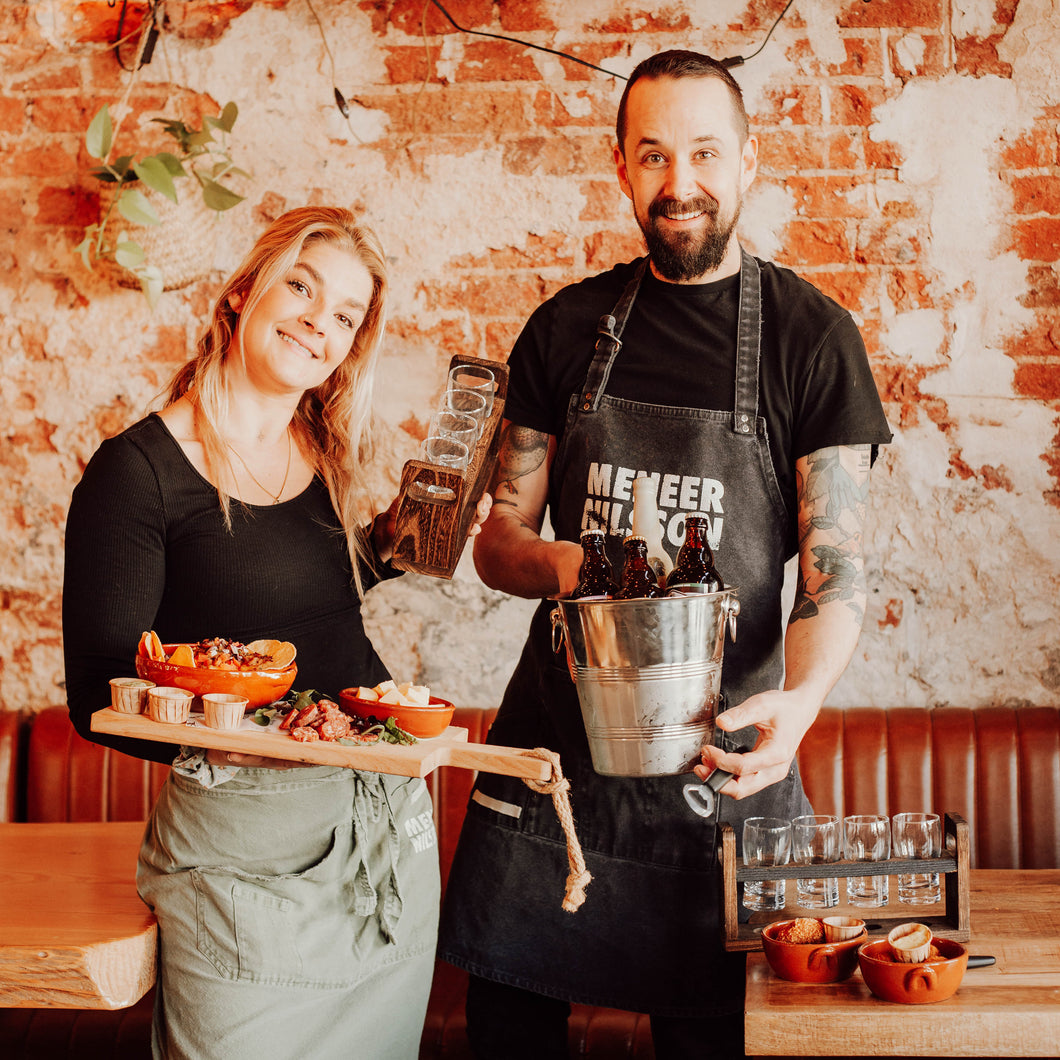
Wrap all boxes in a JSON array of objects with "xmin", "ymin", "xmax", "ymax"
[{"xmin": 744, "ymin": 869, "xmax": 1060, "ymax": 1057}]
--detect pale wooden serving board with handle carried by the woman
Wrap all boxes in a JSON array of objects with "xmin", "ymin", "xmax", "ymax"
[{"xmin": 92, "ymin": 707, "xmax": 552, "ymax": 780}]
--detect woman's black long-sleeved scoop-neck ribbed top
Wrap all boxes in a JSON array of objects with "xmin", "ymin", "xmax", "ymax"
[{"xmin": 63, "ymin": 416, "xmax": 398, "ymax": 762}]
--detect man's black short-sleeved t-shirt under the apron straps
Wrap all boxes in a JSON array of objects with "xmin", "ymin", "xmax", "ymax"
[{"xmin": 505, "ymin": 254, "xmax": 891, "ymax": 511}]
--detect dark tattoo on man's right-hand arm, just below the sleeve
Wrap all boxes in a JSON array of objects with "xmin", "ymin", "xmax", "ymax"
[{"xmin": 790, "ymin": 445, "xmax": 871, "ymax": 622}]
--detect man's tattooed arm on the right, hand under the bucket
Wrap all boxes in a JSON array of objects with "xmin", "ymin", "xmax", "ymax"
[{"xmin": 695, "ymin": 445, "xmax": 870, "ymax": 798}]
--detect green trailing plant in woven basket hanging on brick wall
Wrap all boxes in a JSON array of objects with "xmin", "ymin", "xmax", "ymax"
[{"xmin": 77, "ymin": 103, "xmax": 248, "ymax": 307}]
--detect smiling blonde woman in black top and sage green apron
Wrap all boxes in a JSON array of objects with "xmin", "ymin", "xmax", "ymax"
[{"xmin": 63, "ymin": 207, "xmax": 487, "ymax": 1060}]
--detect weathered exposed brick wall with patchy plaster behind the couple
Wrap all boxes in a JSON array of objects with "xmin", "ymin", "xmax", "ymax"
[{"xmin": 0, "ymin": 0, "xmax": 1060, "ymax": 709}]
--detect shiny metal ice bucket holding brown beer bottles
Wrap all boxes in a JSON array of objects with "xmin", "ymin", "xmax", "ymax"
[{"xmin": 551, "ymin": 588, "xmax": 740, "ymax": 777}]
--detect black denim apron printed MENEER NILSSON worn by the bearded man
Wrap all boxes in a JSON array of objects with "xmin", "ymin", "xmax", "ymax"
[{"xmin": 439, "ymin": 252, "xmax": 810, "ymax": 1015}]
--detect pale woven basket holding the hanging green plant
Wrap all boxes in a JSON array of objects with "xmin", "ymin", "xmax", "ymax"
[{"xmin": 100, "ymin": 177, "xmax": 218, "ymax": 290}]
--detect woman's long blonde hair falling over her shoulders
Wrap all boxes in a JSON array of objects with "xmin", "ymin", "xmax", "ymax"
[{"xmin": 165, "ymin": 207, "xmax": 388, "ymax": 594}]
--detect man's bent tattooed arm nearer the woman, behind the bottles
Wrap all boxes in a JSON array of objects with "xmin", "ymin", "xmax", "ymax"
[{"xmin": 474, "ymin": 420, "xmax": 582, "ymax": 600}]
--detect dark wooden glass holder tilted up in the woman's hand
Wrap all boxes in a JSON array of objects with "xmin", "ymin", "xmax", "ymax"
[{"xmin": 392, "ymin": 356, "xmax": 508, "ymax": 578}]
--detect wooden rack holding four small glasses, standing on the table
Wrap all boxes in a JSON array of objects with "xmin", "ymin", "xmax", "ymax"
[{"xmin": 720, "ymin": 813, "xmax": 971, "ymax": 951}]
